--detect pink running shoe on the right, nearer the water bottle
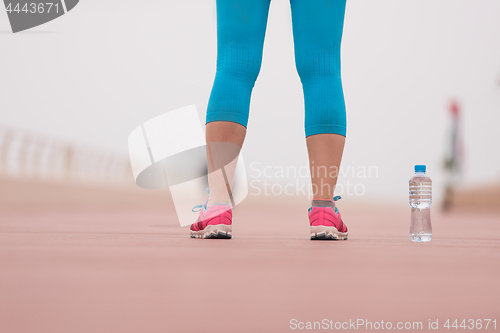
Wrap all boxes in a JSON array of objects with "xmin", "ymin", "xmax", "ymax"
[{"xmin": 308, "ymin": 196, "xmax": 347, "ymax": 240}]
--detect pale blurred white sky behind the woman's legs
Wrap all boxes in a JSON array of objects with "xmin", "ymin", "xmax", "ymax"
[{"xmin": 0, "ymin": 0, "xmax": 500, "ymax": 204}]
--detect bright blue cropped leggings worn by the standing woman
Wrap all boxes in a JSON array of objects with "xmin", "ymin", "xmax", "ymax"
[{"xmin": 206, "ymin": 0, "xmax": 346, "ymax": 137}]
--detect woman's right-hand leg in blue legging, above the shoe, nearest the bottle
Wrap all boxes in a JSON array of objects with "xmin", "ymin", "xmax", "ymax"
[{"xmin": 290, "ymin": 0, "xmax": 346, "ymax": 200}]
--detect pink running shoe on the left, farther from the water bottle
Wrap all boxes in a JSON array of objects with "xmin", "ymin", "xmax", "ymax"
[{"xmin": 190, "ymin": 200, "xmax": 233, "ymax": 239}]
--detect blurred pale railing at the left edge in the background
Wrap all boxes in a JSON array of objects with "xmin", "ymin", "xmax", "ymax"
[{"xmin": 0, "ymin": 125, "xmax": 133, "ymax": 186}]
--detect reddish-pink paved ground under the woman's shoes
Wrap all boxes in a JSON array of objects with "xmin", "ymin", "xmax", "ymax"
[{"xmin": 0, "ymin": 180, "xmax": 500, "ymax": 333}]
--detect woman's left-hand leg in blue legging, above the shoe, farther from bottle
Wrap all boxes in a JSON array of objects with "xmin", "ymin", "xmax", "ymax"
[{"xmin": 206, "ymin": 0, "xmax": 270, "ymax": 205}]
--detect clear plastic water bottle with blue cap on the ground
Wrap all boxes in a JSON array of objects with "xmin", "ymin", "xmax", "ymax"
[{"xmin": 410, "ymin": 165, "xmax": 432, "ymax": 242}]
